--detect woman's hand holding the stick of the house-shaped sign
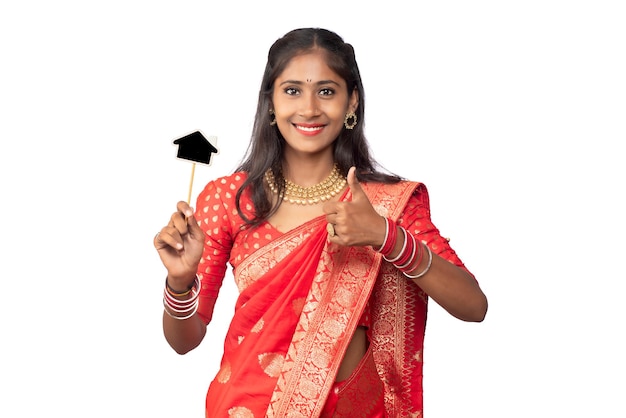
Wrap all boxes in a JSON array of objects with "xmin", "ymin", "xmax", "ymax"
[{"xmin": 154, "ymin": 202, "xmax": 205, "ymax": 291}]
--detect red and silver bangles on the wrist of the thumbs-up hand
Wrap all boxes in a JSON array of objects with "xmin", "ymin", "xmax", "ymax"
[{"xmin": 376, "ymin": 218, "xmax": 433, "ymax": 279}]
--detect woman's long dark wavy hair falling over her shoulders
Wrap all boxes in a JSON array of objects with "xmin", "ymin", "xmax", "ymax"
[{"xmin": 235, "ymin": 28, "xmax": 402, "ymax": 226}]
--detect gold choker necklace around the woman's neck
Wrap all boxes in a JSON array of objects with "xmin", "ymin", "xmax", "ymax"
[{"xmin": 265, "ymin": 164, "xmax": 347, "ymax": 205}]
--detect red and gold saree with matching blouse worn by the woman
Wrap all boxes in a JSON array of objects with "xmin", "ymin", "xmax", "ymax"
[{"xmin": 196, "ymin": 173, "xmax": 470, "ymax": 418}]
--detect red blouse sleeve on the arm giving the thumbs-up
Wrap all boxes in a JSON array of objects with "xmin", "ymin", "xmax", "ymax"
[{"xmin": 398, "ymin": 183, "xmax": 472, "ymax": 274}]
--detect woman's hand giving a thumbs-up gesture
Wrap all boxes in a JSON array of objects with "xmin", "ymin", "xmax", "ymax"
[{"xmin": 324, "ymin": 167, "xmax": 386, "ymax": 248}]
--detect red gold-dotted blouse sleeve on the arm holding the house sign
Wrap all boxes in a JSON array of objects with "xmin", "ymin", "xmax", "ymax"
[{"xmin": 196, "ymin": 181, "xmax": 233, "ymax": 324}]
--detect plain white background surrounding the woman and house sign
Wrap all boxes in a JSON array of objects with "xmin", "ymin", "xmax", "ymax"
[{"xmin": 0, "ymin": 0, "xmax": 626, "ymax": 418}]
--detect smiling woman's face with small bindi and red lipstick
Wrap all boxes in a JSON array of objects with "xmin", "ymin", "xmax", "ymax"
[{"xmin": 272, "ymin": 51, "xmax": 358, "ymax": 158}]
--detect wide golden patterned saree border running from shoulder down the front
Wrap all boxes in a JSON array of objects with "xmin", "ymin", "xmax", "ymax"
[{"xmin": 266, "ymin": 182, "xmax": 418, "ymax": 418}]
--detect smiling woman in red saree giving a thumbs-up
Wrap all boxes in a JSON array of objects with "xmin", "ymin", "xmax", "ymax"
[{"xmin": 154, "ymin": 28, "xmax": 487, "ymax": 417}]
